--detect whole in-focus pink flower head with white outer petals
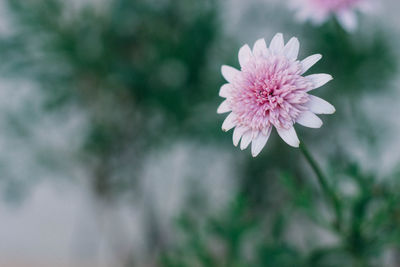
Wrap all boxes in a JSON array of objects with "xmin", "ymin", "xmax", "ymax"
[{"xmin": 217, "ymin": 33, "xmax": 335, "ymax": 157}]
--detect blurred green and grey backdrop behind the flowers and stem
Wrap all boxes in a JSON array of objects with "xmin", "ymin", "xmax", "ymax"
[{"xmin": 0, "ymin": 0, "xmax": 400, "ymax": 267}]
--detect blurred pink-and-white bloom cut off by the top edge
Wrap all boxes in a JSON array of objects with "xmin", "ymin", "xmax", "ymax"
[{"xmin": 290, "ymin": 0, "xmax": 372, "ymax": 31}]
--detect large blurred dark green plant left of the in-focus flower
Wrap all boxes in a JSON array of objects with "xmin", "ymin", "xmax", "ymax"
[{"xmin": 0, "ymin": 0, "xmax": 229, "ymax": 262}]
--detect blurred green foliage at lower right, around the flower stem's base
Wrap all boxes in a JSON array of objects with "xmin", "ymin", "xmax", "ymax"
[{"xmin": 161, "ymin": 160, "xmax": 400, "ymax": 267}]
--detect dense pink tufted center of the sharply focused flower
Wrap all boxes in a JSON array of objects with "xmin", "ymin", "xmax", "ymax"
[{"xmin": 229, "ymin": 56, "xmax": 311, "ymax": 131}]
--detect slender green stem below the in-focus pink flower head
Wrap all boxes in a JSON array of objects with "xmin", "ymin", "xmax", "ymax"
[{"xmin": 300, "ymin": 142, "xmax": 342, "ymax": 230}]
